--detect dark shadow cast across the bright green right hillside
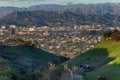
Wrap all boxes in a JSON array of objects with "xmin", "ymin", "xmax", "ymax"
[{"xmin": 68, "ymin": 48, "xmax": 115, "ymax": 68}]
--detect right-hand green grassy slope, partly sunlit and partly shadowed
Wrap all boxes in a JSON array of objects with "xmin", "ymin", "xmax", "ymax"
[{"xmin": 68, "ymin": 41, "xmax": 120, "ymax": 80}]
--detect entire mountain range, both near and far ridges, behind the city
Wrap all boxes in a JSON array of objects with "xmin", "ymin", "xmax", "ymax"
[{"xmin": 0, "ymin": 3, "xmax": 120, "ymax": 26}]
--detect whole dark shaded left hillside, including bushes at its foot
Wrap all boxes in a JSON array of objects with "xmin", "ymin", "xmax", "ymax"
[{"xmin": 0, "ymin": 45, "xmax": 66, "ymax": 80}]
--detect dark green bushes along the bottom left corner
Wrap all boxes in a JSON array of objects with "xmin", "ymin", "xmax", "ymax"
[{"xmin": 0, "ymin": 69, "xmax": 43, "ymax": 80}]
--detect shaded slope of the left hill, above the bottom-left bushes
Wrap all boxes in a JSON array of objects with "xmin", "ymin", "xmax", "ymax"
[{"xmin": 0, "ymin": 46, "xmax": 64, "ymax": 68}]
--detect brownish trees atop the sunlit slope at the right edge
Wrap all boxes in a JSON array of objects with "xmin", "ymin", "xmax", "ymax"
[{"xmin": 104, "ymin": 30, "xmax": 120, "ymax": 41}]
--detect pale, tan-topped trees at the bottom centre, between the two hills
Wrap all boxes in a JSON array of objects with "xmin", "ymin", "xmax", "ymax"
[{"xmin": 48, "ymin": 62, "xmax": 79, "ymax": 80}]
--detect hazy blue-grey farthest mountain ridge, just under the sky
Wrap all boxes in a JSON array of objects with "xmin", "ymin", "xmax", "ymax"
[{"xmin": 0, "ymin": 3, "xmax": 120, "ymax": 17}]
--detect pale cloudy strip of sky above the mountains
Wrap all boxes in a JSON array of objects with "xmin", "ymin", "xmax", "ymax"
[{"xmin": 0, "ymin": 0, "xmax": 120, "ymax": 7}]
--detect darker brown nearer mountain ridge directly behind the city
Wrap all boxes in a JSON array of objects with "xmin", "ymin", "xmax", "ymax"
[{"xmin": 0, "ymin": 10, "xmax": 120, "ymax": 27}]
